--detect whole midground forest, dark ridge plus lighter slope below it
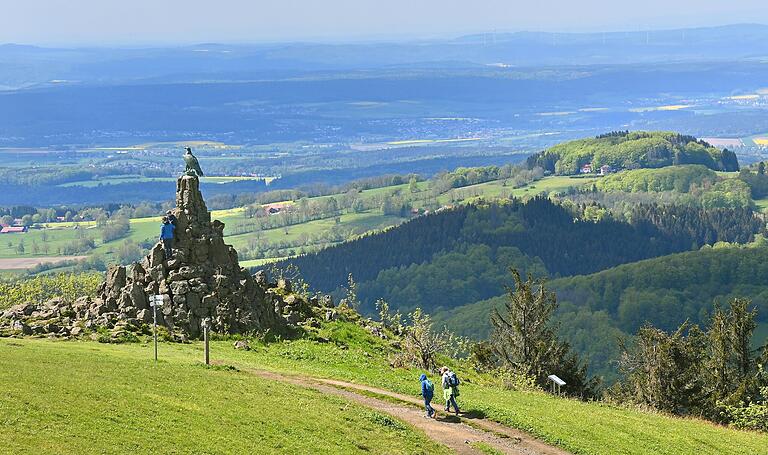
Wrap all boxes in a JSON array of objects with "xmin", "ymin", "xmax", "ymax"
[{"xmin": 278, "ymin": 197, "xmax": 768, "ymax": 380}]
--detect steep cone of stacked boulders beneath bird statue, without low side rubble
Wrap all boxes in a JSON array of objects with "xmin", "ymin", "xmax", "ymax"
[{"xmin": 99, "ymin": 175, "xmax": 285, "ymax": 338}]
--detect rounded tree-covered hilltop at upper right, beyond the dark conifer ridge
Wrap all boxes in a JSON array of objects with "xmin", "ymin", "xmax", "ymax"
[{"xmin": 528, "ymin": 131, "xmax": 739, "ymax": 175}]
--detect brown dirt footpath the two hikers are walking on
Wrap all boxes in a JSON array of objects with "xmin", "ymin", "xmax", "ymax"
[{"xmin": 243, "ymin": 368, "xmax": 568, "ymax": 455}]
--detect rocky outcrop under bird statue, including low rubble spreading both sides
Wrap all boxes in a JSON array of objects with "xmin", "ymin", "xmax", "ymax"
[{"xmin": 0, "ymin": 175, "xmax": 333, "ymax": 338}]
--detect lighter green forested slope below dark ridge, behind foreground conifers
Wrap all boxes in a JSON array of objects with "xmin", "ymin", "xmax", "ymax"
[{"xmin": 436, "ymin": 246, "xmax": 768, "ymax": 378}]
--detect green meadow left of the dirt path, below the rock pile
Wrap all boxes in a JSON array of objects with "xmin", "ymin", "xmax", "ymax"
[{"xmin": 0, "ymin": 339, "xmax": 449, "ymax": 454}]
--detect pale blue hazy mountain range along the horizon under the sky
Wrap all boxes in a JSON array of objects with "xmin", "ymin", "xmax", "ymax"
[{"xmin": 0, "ymin": 24, "xmax": 768, "ymax": 90}]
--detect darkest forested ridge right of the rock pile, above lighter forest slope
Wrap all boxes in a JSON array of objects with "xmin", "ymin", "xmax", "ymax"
[{"xmin": 278, "ymin": 197, "xmax": 762, "ymax": 311}]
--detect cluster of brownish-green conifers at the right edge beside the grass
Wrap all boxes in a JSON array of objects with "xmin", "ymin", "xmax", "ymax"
[{"xmin": 614, "ymin": 298, "xmax": 768, "ymax": 423}]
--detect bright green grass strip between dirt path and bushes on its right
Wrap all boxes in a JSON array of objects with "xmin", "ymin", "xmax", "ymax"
[{"xmin": 206, "ymin": 324, "xmax": 768, "ymax": 455}]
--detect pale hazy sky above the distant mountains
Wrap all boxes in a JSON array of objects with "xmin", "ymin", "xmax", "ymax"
[{"xmin": 0, "ymin": 0, "xmax": 768, "ymax": 45}]
